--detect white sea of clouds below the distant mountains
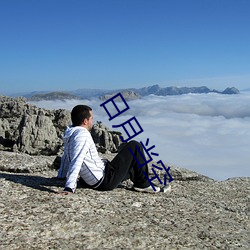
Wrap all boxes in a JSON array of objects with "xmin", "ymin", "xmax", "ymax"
[{"xmin": 32, "ymin": 92, "xmax": 250, "ymax": 180}]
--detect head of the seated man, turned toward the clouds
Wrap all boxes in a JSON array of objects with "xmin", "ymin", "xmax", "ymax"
[{"xmin": 71, "ymin": 105, "xmax": 93, "ymax": 131}]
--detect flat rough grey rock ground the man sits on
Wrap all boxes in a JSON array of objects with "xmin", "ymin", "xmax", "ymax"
[{"xmin": 0, "ymin": 152, "xmax": 250, "ymax": 249}]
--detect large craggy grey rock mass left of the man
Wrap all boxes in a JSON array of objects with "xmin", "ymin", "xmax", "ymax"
[{"xmin": 0, "ymin": 97, "xmax": 63, "ymax": 155}]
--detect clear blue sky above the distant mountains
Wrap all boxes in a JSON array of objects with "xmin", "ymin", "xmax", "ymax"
[{"xmin": 0, "ymin": 0, "xmax": 250, "ymax": 94}]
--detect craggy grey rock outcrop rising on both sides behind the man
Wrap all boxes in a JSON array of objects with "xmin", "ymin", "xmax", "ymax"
[{"xmin": 0, "ymin": 96, "xmax": 123, "ymax": 155}]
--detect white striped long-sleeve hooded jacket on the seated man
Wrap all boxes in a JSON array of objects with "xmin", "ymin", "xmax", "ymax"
[{"xmin": 58, "ymin": 126, "xmax": 105, "ymax": 192}]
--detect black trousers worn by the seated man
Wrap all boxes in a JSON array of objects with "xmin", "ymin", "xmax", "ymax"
[{"xmin": 97, "ymin": 141, "xmax": 150, "ymax": 191}]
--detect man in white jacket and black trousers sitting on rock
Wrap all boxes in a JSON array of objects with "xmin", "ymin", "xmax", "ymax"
[{"xmin": 58, "ymin": 105, "xmax": 164, "ymax": 193}]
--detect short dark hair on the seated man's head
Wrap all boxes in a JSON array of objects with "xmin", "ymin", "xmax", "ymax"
[{"xmin": 71, "ymin": 105, "xmax": 92, "ymax": 127}]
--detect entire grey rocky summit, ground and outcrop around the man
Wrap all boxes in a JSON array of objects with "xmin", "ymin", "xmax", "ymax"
[{"xmin": 0, "ymin": 94, "xmax": 250, "ymax": 249}]
